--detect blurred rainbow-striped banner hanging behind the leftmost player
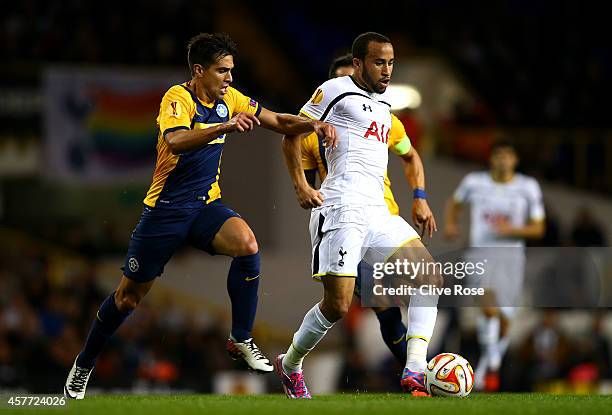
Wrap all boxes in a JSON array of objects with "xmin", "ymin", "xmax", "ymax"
[{"xmin": 42, "ymin": 67, "xmax": 185, "ymax": 182}]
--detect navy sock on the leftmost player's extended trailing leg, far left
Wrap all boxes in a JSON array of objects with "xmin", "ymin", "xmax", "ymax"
[{"xmin": 77, "ymin": 292, "xmax": 132, "ymax": 368}]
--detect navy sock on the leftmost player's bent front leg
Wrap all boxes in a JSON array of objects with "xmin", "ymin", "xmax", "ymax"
[{"xmin": 227, "ymin": 252, "xmax": 259, "ymax": 342}]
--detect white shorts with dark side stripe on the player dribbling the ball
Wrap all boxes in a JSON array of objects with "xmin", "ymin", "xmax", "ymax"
[{"xmin": 310, "ymin": 205, "xmax": 419, "ymax": 279}]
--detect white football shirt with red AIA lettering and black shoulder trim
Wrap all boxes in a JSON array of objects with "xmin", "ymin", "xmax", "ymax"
[{"xmin": 300, "ymin": 76, "xmax": 391, "ymax": 206}]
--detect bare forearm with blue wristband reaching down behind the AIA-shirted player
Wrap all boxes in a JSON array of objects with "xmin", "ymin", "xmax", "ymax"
[{"xmin": 400, "ymin": 148, "xmax": 438, "ymax": 238}]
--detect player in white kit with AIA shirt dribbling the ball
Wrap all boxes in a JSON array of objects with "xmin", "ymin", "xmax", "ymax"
[{"xmin": 275, "ymin": 32, "xmax": 442, "ymax": 398}]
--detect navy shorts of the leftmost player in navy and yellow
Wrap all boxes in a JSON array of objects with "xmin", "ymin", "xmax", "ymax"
[{"xmin": 121, "ymin": 199, "xmax": 240, "ymax": 282}]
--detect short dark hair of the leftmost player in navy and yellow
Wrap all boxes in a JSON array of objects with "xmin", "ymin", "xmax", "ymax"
[{"xmin": 187, "ymin": 33, "xmax": 238, "ymax": 74}]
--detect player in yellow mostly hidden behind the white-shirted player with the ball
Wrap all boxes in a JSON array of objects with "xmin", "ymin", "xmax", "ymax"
[{"xmin": 301, "ymin": 54, "xmax": 422, "ymax": 364}]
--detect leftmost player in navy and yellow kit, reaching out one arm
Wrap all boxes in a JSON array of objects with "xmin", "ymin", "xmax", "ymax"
[{"xmin": 64, "ymin": 33, "xmax": 335, "ymax": 399}]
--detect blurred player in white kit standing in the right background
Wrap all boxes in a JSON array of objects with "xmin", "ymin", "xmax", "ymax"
[{"xmin": 445, "ymin": 140, "xmax": 544, "ymax": 392}]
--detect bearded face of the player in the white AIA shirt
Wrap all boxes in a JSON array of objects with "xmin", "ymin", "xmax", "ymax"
[{"xmin": 360, "ymin": 42, "xmax": 394, "ymax": 94}]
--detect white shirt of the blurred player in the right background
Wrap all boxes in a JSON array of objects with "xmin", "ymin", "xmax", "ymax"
[{"xmin": 454, "ymin": 172, "xmax": 544, "ymax": 247}]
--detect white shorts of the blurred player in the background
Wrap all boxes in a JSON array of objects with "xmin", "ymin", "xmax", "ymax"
[{"xmin": 465, "ymin": 248, "xmax": 526, "ymax": 317}]
